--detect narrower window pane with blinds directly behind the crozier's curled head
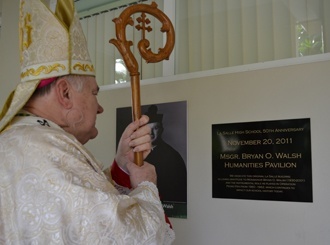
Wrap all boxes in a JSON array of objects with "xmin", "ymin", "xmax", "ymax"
[{"xmin": 77, "ymin": 0, "xmax": 163, "ymax": 85}]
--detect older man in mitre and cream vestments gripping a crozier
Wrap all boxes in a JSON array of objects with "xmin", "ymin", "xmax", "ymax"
[{"xmin": 0, "ymin": 0, "xmax": 174, "ymax": 244}]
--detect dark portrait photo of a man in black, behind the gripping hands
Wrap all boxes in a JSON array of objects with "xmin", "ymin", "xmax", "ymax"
[{"xmin": 116, "ymin": 101, "xmax": 187, "ymax": 218}]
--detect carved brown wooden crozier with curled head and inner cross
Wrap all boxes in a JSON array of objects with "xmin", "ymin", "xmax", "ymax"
[{"xmin": 110, "ymin": 2, "xmax": 175, "ymax": 166}]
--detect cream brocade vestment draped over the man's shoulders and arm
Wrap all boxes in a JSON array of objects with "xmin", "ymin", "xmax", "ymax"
[{"xmin": 0, "ymin": 115, "xmax": 174, "ymax": 245}]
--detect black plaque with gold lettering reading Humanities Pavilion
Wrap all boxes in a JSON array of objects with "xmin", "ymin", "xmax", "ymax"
[{"xmin": 212, "ymin": 118, "xmax": 313, "ymax": 202}]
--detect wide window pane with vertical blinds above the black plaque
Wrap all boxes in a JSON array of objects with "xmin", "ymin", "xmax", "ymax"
[{"xmin": 175, "ymin": 0, "xmax": 330, "ymax": 74}]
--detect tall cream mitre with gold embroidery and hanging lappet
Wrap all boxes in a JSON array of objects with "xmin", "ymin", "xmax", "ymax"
[{"xmin": 0, "ymin": 0, "xmax": 95, "ymax": 132}]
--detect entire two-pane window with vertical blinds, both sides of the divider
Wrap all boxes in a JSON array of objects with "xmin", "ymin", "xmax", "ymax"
[{"xmin": 81, "ymin": 0, "xmax": 330, "ymax": 85}]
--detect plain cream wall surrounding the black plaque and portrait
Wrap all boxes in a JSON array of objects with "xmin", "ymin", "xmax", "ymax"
[{"xmin": 0, "ymin": 0, "xmax": 330, "ymax": 245}]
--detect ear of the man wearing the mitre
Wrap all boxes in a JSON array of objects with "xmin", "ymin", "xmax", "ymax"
[{"xmin": 56, "ymin": 77, "xmax": 73, "ymax": 109}]
